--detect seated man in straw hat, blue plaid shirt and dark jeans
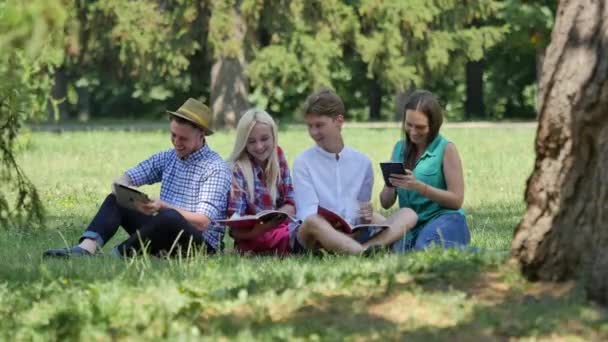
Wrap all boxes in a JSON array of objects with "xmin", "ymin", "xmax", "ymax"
[{"xmin": 44, "ymin": 99, "xmax": 231, "ymax": 257}]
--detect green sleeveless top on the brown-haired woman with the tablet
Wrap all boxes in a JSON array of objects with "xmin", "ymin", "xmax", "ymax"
[{"xmin": 391, "ymin": 135, "xmax": 464, "ymax": 240}]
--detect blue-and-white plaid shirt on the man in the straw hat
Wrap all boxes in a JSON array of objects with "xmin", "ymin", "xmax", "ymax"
[{"xmin": 127, "ymin": 145, "xmax": 232, "ymax": 250}]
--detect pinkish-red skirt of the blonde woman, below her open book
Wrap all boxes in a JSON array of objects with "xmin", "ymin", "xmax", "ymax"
[{"xmin": 235, "ymin": 220, "xmax": 290, "ymax": 255}]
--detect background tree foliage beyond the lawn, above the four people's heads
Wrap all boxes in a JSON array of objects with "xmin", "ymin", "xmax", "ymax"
[{"xmin": 4, "ymin": 0, "xmax": 556, "ymax": 121}]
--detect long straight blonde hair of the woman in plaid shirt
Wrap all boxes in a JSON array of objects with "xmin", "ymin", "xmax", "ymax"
[{"xmin": 228, "ymin": 108, "xmax": 279, "ymax": 205}]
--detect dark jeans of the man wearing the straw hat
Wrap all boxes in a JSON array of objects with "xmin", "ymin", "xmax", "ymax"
[{"xmin": 80, "ymin": 194, "xmax": 215, "ymax": 256}]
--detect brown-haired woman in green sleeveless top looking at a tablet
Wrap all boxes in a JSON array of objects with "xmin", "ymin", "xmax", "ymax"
[{"xmin": 380, "ymin": 90, "xmax": 471, "ymax": 252}]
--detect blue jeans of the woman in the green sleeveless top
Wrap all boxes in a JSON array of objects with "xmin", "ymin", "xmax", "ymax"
[{"xmin": 393, "ymin": 213, "xmax": 471, "ymax": 253}]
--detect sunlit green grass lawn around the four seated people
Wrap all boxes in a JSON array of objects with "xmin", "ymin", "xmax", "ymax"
[{"xmin": 0, "ymin": 128, "xmax": 608, "ymax": 341}]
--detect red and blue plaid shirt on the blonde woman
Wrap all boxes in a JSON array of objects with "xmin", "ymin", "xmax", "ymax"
[{"xmin": 228, "ymin": 147, "xmax": 295, "ymax": 217}]
